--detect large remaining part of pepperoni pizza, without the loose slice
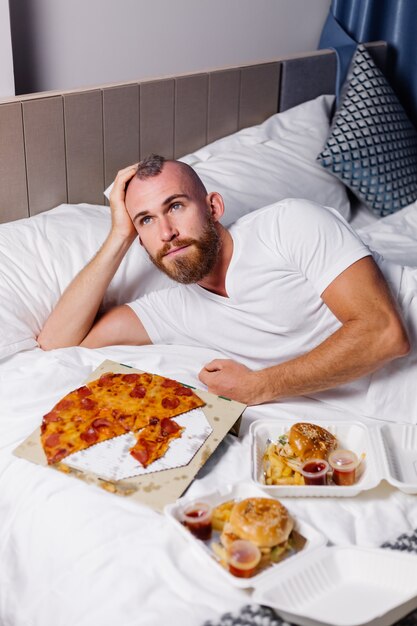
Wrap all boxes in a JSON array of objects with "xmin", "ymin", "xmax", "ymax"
[{"xmin": 41, "ymin": 372, "xmax": 204, "ymax": 464}]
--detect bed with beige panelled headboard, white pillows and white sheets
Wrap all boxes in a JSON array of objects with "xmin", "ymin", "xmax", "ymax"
[{"xmin": 0, "ymin": 42, "xmax": 417, "ymax": 626}]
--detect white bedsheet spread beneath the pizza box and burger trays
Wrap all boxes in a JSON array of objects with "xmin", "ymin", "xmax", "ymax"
[{"xmin": 0, "ymin": 202, "xmax": 417, "ymax": 626}]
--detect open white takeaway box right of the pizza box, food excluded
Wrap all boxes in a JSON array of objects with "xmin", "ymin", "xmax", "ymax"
[{"xmin": 250, "ymin": 419, "xmax": 417, "ymax": 497}]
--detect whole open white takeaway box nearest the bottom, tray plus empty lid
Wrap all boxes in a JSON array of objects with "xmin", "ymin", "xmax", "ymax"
[{"xmin": 164, "ymin": 483, "xmax": 417, "ymax": 626}]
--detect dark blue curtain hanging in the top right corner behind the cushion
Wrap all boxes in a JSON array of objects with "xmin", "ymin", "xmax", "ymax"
[{"xmin": 320, "ymin": 0, "xmax": 417, "ymax": 126}]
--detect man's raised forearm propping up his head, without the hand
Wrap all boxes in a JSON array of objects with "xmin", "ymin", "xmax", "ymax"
[{"xmin": 38, "ymin": 233, "xmax": 133, "ymax": 350}]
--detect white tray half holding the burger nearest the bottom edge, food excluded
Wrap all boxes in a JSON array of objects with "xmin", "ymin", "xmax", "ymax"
[{"xmin": 164, "ymin": 483, "xmax": 327, "ymax": 588}]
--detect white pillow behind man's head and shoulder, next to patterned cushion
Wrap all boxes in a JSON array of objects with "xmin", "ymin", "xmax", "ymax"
[{"xmin": 105, "ymin": 95, "xmax": 350, "ymax": 226}]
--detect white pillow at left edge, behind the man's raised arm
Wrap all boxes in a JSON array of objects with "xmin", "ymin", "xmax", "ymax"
[{"xmin": 0, "ymin": 204, "xmax": 172, "ymax": 358}]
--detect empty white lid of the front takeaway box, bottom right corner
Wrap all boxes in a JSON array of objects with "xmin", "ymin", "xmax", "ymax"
[{"xmin": 252, "ymin": 547, "xmax": 417, "ymax": 626}]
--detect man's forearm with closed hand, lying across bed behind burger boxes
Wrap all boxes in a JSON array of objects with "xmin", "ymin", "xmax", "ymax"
[{"xmin": 199, "ymin": 318, "xmax": 409, "ymax": 405}]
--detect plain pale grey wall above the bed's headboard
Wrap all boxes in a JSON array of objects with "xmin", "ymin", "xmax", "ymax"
[{"xmin": 8, "ymin": 0, "xmax": 330, "ymax": 94}]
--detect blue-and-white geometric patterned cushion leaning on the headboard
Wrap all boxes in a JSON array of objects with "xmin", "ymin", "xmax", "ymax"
[{"xmin": 317, "ymin": 45, "xmax": 417, "ymax": 216}]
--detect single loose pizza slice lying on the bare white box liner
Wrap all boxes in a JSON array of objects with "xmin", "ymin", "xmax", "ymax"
[{"xmin": 130, "ymin": 417, "xmax": 184, "ymax": 467}]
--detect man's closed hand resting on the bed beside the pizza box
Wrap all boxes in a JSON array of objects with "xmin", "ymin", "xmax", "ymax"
[{"xmin": 198, "ymin": 359, "xmax": 268, "ymax": 405}]
